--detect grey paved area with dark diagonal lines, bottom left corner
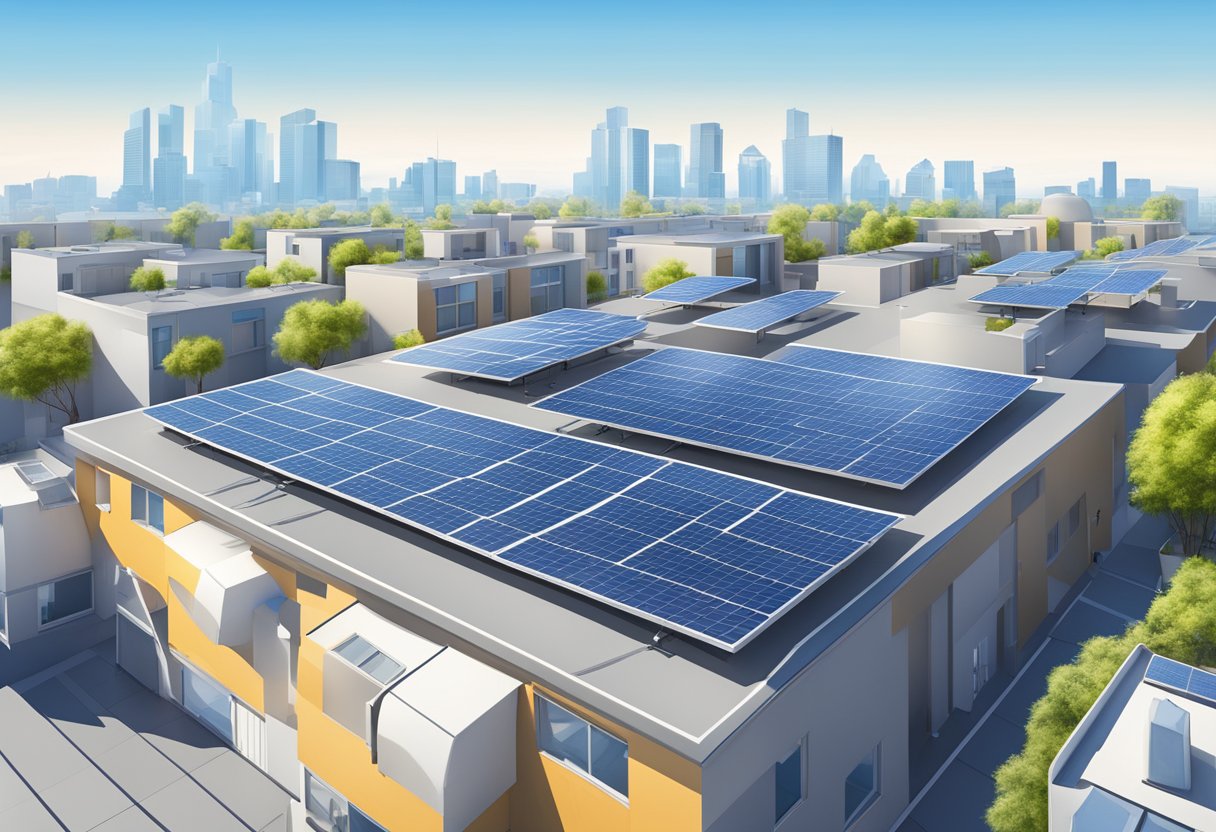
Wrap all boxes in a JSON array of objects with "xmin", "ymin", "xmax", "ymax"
[{"xmin": 0, "ymin": 642, "xmax": 291, "ymax": 832}]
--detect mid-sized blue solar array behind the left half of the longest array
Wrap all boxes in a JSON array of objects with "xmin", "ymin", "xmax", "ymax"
[{"xmin": 389, "ymin": 309, "xmax": 646, "ymax": 382}]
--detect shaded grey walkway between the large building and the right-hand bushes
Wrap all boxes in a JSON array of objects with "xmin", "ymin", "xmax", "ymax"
[{"xmin": 897, "ymin": 517, "xmax": 1167, "ymax": 832}]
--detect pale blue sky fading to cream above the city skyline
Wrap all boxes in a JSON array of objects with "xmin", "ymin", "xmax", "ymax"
[{"xmin": 0, "ymin": 0, "xmax": 1216, "ymax": 195}]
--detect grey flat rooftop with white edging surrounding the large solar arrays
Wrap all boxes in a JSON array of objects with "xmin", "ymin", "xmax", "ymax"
[{"xmin": 66, "ymin": 299, "xmax": 1121, "ymax": 760}]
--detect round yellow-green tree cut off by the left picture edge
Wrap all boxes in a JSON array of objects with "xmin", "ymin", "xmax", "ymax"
[{"xmin": 0, "ymin": 314, "xmax": 92, "ymax": 422}]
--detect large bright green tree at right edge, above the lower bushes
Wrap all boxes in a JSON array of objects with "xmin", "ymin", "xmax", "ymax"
[{"xmin": 1127, "ymin": 372, "xmax": 1216, "ymax": 555}]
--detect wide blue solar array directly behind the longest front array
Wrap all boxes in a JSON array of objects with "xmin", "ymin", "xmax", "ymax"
[{"xmin": 533, "ymin": 347, "xmax": 1035, "ymax": 488}]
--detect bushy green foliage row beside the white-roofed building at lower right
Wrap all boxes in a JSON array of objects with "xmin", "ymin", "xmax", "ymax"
[{"xmin": 987, "ymin": 557, "xmax": 1216, "ymax": 832}]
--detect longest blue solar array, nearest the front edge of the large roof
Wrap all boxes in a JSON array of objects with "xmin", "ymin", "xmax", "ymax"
[{"xmin": 145, "ymin": 370, "xmax": 899, "ymax": 652}]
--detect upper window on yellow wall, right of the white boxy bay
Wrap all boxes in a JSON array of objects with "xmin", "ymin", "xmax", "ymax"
[{"xmin": 536, "ymin": 696, "xmax": 629, "ymax": 799}]
